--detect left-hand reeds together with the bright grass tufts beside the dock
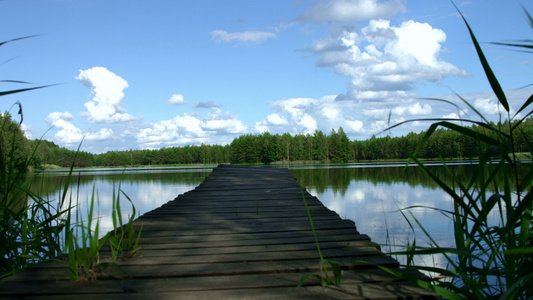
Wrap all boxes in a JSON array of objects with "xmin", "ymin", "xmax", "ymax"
[{"xmin": 0, "ymin": 37, "xmax": 140, "ymax": 280}]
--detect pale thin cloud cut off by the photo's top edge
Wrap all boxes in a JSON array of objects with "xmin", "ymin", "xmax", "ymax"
[{"xmin": 296, "ymin": 0, "xmax": 405, "ymax": 23}]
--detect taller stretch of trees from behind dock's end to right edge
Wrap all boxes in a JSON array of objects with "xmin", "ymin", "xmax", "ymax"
[{"xmin": 231, "ymin": 118, "xmax": 533, "ymax": 164}]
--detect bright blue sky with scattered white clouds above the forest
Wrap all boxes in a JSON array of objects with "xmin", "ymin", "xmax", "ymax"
[{"xmin": 0, "ymin": 0, "xmax": 533, "ymax": 153}]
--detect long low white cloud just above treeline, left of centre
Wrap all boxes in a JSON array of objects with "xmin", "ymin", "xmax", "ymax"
[{"xmin": 135, "ymin": 112, "xmax": 248, "ymax": 149}]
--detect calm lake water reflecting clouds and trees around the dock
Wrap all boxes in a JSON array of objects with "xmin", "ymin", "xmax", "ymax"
[{"xmin": 32, "ymin": 161, "xmax": 486, "ymax": 266}]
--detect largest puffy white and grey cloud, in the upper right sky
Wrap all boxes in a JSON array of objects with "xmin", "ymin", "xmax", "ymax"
[{"xmin": 307, "ymin": 17, "xmax": 466, "ymax": 101}]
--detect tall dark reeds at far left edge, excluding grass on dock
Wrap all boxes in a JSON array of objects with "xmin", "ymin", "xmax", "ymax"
[{"xmin": 0, "ymin": 41, "xmax": 66, "ymax": 278}]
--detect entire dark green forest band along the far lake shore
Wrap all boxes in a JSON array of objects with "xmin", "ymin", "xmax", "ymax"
[{"xmin": 0, "ymin": 113, "xmax": 533, "ymax": 169}]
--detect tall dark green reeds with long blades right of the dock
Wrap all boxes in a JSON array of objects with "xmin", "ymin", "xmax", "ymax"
[{"xmin": 383, "ymin": 5, "xmax": 533, "ymax": 299}]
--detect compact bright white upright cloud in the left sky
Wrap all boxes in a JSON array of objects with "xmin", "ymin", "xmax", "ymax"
[{"xmin": 76, "ymin": 67, "xmax": 136, "ymax": 123}]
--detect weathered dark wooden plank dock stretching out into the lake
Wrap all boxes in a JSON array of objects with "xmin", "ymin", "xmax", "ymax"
[{"xmin": 0, "ymin": 165, "xmax": 437, "ymax": 300}]
